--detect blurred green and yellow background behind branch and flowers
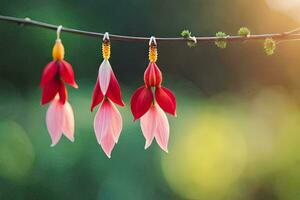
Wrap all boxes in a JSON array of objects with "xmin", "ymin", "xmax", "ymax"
[{"xmin": 0, "ymin": 0, "xmax": 300, "ymax": 200}]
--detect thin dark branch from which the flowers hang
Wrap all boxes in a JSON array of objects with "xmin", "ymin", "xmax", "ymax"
[{"xmin": 0, "ymin": 15, "xmax": 300, "ymax": 42}]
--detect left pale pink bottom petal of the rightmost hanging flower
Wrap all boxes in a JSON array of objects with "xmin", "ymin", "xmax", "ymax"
[{"xmin": 140, "ymin": 106, "xmax": 157, "ymax": 149}]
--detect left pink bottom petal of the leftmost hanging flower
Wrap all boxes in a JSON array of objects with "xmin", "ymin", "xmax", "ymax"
[{"xmin": 46, "ymin": 99, "xmax": 64, "ymax": 146}]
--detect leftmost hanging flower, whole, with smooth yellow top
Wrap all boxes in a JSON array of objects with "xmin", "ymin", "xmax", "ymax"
[{"xmin": 40, "ymin": 30, "xmax": 78, "ymax": 146}]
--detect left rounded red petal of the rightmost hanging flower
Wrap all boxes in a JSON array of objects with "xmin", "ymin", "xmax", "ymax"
[{"xmin": 130, "ymin": 86, "xmax": 153, "ymax": 120}]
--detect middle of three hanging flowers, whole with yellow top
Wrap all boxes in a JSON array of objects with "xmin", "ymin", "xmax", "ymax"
[{"xmin": 91, "ymin": 33, "xmax": 125, "ymax": 158}]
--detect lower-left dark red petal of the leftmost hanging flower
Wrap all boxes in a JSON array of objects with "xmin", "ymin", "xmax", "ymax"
[{"xmin": 41, "ymin": 79, "xmax": 60, "ymax": 105}]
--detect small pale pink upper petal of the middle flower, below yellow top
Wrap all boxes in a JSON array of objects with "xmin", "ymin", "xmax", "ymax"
[{"xmin": 98, "ymin": 60, "xmax": 112, "ymax": 95}]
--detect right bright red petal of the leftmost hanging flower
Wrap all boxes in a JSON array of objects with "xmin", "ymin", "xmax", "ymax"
[{"xmin": 58, "ymin": 60, "xmax": 78, "ymax": 88}]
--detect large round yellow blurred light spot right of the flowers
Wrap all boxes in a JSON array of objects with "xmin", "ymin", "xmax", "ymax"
[{"xmin": 162, "ymin": 109, "xmax": 246, "ymax": 199}]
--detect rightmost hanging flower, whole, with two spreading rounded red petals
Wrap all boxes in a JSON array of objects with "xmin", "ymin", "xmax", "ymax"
[{"xmin": 131, "ymin": 37, "xmax": 176, "ymax": 152}]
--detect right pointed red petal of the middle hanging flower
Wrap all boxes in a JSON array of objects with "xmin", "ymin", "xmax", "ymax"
[{"xmin": 106, "ymin": 72, "xmax": 125, "ymax": 106}]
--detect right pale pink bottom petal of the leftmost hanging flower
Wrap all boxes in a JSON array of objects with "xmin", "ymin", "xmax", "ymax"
[{"xmin": 62, "ymin": 102, "xmax": 74, "ymax": 142}]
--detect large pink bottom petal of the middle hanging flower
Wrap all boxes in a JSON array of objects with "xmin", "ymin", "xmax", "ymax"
[{"xmin": 94, "ymin": 99, "xmax": 122, "ymax": 157}]
